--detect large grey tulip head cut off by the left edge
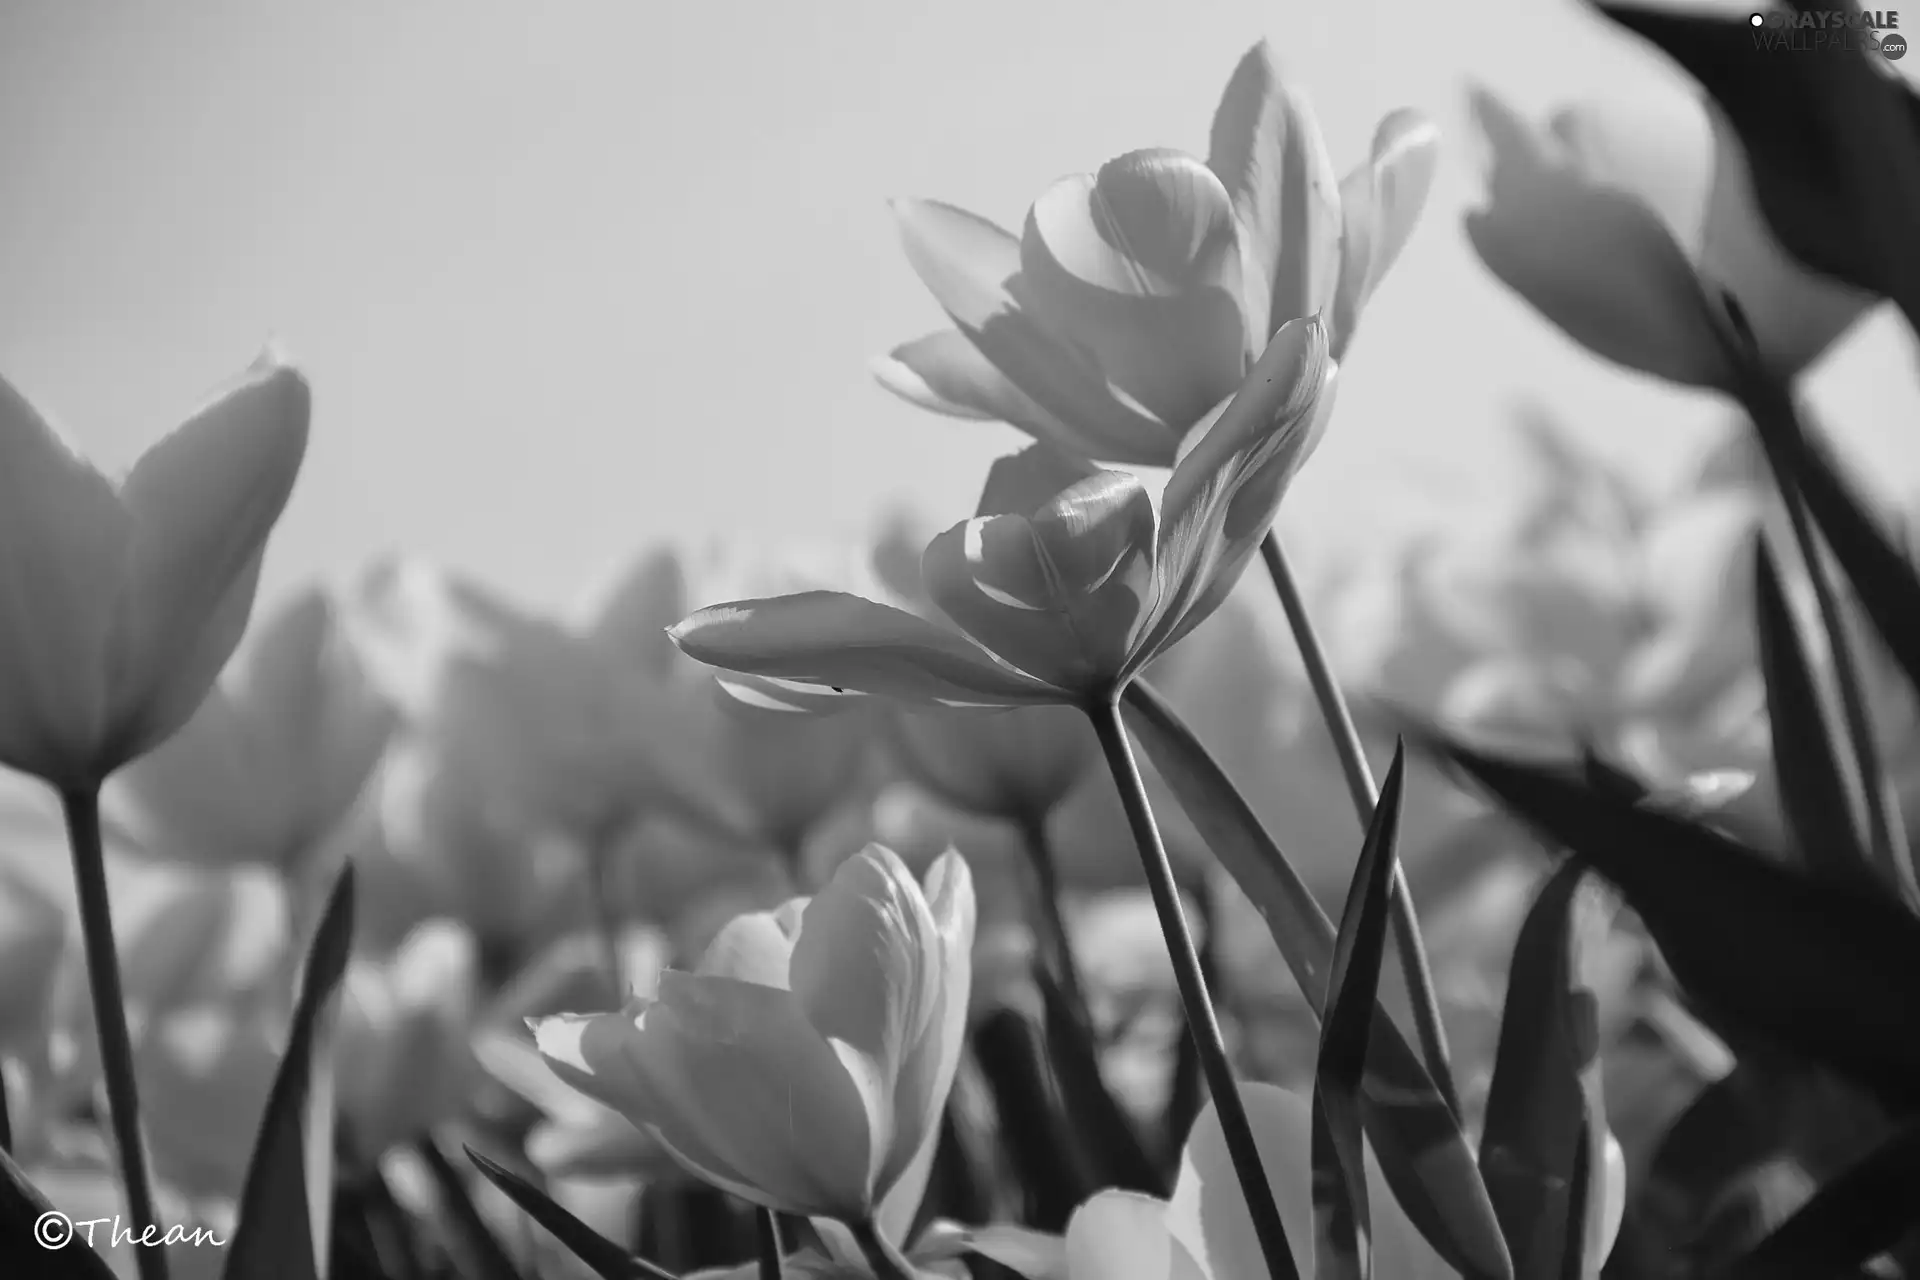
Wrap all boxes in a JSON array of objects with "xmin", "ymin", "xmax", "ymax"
[{"xmin": 0, "ymin": 351, "xmax": 309, "ymax": 793}]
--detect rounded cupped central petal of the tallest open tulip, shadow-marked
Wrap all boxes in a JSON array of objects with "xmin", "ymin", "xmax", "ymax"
[{"xmin": 1016, "ymin": 150, "xmax": 1265, "ymax": 441}]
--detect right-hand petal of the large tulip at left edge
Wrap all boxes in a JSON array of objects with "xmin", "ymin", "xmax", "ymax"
[{"xmin": 102, "ymin": 357, "xmax": 311, "ymax": 766}]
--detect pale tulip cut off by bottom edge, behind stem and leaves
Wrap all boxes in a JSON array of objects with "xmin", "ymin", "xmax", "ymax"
[{"xmin": 1025, "ymin": 1084, "xmax": 1626, "ymax": 1280}]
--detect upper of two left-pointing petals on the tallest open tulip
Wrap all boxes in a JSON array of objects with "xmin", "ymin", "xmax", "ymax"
[{"xmin": 893, "ymin": 200, "xmax": 1179, "ymax": 466}]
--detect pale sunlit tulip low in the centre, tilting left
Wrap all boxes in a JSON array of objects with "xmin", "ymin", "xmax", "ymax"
[{"xmin": 534, "ymin": 846, "xmax": 973, "ymax": 1240}]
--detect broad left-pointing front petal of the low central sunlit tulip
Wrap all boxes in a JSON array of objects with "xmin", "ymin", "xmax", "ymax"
[{"xmin": 534, "ymin": 971, "xmax": 872, "ymax": 1219}]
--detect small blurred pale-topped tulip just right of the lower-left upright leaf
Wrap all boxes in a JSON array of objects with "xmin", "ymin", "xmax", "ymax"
[{"xmin": 334, "ymin": 921, "xmax": 478, "ymax": 1159}]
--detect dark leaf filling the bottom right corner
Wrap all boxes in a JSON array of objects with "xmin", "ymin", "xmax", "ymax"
[{"xmin": 1716, "ymin": 1121, "xmax": 1920, "ymax": 1280}]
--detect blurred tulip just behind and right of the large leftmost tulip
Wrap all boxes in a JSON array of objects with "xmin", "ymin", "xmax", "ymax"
[{"xmin": 109, "ymin": 589, "xmax": 394, "ymax": 873}]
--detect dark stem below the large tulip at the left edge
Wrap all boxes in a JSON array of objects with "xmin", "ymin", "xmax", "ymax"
[{"xmin": 60, "ymin": 789, "xmax": 167, "ymax": 1280}]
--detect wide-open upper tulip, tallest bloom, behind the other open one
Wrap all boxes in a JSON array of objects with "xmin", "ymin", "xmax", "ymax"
[{"xmin": 876, "ymin": 42, "xmax": 1436, "ymax": 466}]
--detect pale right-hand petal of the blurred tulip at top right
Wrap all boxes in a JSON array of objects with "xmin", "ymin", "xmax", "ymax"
[{"xmin": 1549, "ymin": 86, "xmax": 1874, "ymax": 374}]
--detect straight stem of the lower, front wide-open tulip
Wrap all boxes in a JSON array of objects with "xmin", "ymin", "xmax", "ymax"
[{"xmin": 1085, "ymin": 699, "xmax": 1300, "ymax": 1280}]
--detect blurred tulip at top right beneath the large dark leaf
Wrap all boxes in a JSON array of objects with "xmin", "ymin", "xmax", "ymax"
[{"xmin": 1467, "ymin": 83, "xmax": 1872, "ymax": 390}]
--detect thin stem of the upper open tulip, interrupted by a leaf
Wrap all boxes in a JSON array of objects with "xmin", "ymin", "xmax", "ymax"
[{"xmin": 1260, "ymin": 530, "xmax": 1461, "ymax": 1119}]
